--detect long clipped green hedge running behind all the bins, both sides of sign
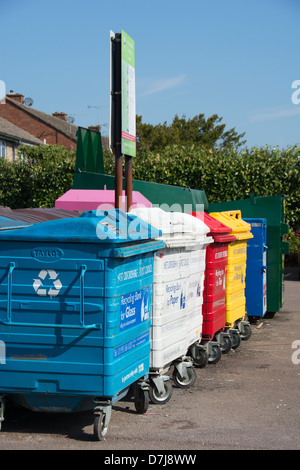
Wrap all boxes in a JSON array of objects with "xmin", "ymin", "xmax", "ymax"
[{"xmin": 0, "ymin": 145, "xmax": 300, "ymax": 250}]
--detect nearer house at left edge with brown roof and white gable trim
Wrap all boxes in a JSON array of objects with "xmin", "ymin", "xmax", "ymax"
[{"xmin": 0, "ymin": 117, "xmax": 43, "ymax": 162}]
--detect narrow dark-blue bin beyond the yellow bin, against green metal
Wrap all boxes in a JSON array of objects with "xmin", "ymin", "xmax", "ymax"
[{"xmin": 244, "ymin": 218, "xmax": 267, "ymax": 322}]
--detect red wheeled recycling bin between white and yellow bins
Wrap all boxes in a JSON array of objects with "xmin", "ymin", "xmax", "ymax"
[{"xmin": 191, "ymin": 212, "xmax": 235, "ymax": 364}]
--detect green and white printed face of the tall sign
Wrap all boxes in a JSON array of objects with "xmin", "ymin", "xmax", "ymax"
[{"xmin": 121, "ymin": 30, "xmax": 136, "ymax": 157}]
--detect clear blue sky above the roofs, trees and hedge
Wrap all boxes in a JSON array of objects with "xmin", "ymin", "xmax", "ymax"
[{"xmin": 0, "ymin": 0, "xmax": 300, "ymax": 147}]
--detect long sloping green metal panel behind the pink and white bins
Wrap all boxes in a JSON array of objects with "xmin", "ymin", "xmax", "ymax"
[{"xmin": 73, "ymin": 170, "xmax": 208, "ymax": 212}]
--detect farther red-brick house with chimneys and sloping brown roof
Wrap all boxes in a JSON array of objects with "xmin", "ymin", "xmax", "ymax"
[{"xmin": 0, "ymin": 92, "xmax": 77, "ymax": 150}]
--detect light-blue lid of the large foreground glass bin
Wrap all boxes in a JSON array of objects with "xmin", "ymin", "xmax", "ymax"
[{"xmin": 0, "ymin": 209, "xmax": 161, "ymax": 244}]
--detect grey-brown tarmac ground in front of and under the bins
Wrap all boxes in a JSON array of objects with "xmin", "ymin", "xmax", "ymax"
[{"xmin": 0, "ymin": 269, "xmax": 300, "ymax": 452}]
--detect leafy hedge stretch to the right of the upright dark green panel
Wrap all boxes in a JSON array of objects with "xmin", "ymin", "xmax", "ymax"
[{"xmin": 105, "ymin": 145, "xmax": 300, "ymax": 230}]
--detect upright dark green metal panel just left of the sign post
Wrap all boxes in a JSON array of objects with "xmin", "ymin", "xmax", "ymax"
[{"xmin": 75, "ymin": 127, "xmax": 104, "ymax": 173}]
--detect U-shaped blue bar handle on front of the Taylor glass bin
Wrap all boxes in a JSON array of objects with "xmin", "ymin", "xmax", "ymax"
[{"xmin": 0, "ymin": 262, "xmax": 101, "ymax": 330}]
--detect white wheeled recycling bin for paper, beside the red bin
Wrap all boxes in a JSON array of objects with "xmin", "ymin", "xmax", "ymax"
[{"xmin": 131, "ymin": 208, "xmax": 213, "ymax": 403}]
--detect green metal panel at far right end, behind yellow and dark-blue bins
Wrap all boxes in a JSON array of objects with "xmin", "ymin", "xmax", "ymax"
[{"xmin": 209, "ymin": 194, "xmax": 289, "ymax": 313}]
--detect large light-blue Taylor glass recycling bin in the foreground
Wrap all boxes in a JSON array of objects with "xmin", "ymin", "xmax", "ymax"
[{"xmin": 0, "ymin": 210, "xmax": 164, "ymax": 439}]
